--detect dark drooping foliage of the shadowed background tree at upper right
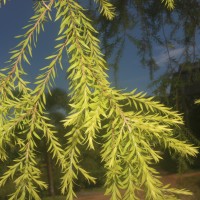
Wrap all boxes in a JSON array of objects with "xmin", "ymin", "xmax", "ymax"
[{"xmin": 90, "ymin": 0, "xmax": 200, "ymax": 90}]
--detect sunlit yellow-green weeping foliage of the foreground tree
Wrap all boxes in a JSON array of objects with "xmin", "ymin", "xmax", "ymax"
[{"xmin": 0, "ymin": 0, "xmax": 197, "ymax": 200}]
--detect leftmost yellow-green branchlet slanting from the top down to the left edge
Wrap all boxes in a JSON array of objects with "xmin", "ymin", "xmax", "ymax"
[{"xmin": 0, "ymin": 1, "xmax": 53, "ymax": 163}]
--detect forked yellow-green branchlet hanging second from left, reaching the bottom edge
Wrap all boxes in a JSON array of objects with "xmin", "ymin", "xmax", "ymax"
[{"xmin": 0, "ymin": 25, "xmax": 71, "ymax": 199}]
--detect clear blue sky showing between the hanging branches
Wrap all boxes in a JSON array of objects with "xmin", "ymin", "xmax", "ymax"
[{"xmin": 0, "ymin": 0, "xmax": 177, "ymax": 93}]
